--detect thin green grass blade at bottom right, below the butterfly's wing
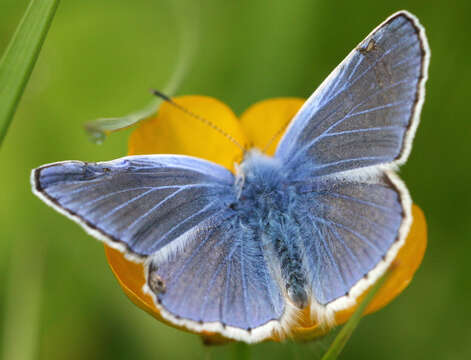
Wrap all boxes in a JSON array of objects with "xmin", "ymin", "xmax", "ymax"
[{"xmin": 322, "ymin": 269, "xmax": 394, "ymax": 360}]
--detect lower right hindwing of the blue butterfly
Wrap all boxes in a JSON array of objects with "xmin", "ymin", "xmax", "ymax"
[{"xmin": 297, "ymin": 173, "xmax": 410, "ymax": 305}]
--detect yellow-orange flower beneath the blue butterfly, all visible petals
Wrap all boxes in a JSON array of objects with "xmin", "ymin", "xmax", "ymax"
[{"xmin": 105, "ymin": 96, "xmax": 427, "ymax": 343}]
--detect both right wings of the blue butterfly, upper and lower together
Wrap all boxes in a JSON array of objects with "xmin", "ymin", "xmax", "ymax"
[{"xmin": 276, "ymin": 12, "xmax": 429, "ymax": 309}]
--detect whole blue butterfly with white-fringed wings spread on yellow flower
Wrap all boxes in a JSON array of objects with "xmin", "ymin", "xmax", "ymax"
[{"xmin": 31, "ymin": 11, "xmax": 430, "ymax": 342}]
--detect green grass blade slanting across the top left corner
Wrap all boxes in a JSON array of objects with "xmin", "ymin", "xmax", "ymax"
[{"xmin": 0, "ymin": 0, "xmax": 59, "ymax": 146}]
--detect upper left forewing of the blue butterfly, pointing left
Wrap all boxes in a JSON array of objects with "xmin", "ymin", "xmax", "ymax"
[{"xmin": 31, "ymin": 155, "xmax": 234, "ymax": 261}]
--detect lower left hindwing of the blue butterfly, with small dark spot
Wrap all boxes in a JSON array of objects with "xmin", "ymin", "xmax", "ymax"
[{"xmin": 148, "ymin": 210, "xmax": 284, "ymax": 335}]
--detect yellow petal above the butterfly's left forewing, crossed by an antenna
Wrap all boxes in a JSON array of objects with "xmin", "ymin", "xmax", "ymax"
[{"xmin": 129, "ymin": 96, "xmax": 247, "ymax": 171}]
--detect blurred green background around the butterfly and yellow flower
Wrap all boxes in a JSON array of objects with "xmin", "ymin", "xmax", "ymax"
[{"xmin": 0, "ymin": 0, "xmax": 471, "ymax": 360}]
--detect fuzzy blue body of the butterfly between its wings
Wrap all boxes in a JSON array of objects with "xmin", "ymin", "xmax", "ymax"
[{"xmin": 231, "ymin": 150, "xmax": 308, "ymax": 309}]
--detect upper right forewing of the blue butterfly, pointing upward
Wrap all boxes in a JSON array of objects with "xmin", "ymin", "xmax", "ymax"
[{"xmin": 276, "ymin": 12, "xmax": 429, "ymax": 176}]
